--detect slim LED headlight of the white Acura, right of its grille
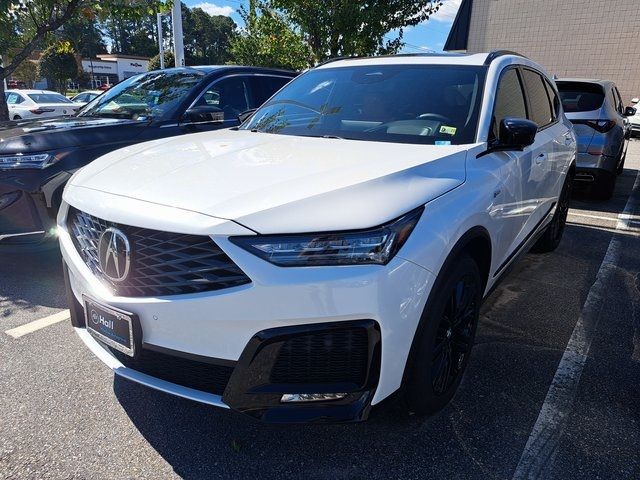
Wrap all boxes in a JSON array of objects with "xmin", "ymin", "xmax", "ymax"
[{"xmin": 229, "ymin": 207, "xmax": 424, "ymax": 267}]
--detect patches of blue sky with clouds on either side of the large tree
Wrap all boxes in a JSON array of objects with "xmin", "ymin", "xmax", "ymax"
[{"xmin": 183, "ymin": 0, "xmax": 462, "ymax": 53}]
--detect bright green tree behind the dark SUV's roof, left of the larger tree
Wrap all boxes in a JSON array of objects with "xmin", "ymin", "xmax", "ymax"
[{"xmin": 231, "ymin": 0, "xmax": 311, "ymax": 70}]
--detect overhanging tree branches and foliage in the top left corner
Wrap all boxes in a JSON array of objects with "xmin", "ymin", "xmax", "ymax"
[{"xmin": 0, "ymin": 0, "xmax": 173, "ymax": 121}]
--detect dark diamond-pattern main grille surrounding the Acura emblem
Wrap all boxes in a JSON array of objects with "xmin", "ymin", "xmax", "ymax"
[{"xmin": 68, "ymin": 208, "xmax": 251, "ymax": 297}]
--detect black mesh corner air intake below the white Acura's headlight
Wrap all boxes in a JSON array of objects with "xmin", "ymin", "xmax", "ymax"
[{"xmin": 271, "ymin": 328, "xmax": 368, "ymax": 386}]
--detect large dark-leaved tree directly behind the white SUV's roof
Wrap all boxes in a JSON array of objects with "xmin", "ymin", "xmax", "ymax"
[{"xmin": 268, "ymin": 0, "xmax": 442, "ymax": 62}]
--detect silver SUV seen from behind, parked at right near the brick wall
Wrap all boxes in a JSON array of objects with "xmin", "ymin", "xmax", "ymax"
[{"xmin": 556, "ymin": 78, "xmax": 635, "ymax": 200}]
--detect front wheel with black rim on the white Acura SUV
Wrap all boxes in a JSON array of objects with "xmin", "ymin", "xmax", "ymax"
[{"xmin": 404, "ymin": 255, "xmax": 483, "ymax": 416}]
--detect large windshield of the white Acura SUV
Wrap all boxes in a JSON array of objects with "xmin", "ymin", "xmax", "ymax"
[{"xmin": 241, "ymin": 65, "xmax": 485, "ymax": 145}]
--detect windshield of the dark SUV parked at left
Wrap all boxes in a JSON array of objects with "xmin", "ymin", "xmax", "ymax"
[{"xmin": 78, "ymin": 69, "xmax": 205, "ymax": 120}]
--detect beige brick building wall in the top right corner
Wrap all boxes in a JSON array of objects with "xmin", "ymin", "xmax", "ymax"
[{"xmin": 467, "ymin": 0, "xmax": 640, "ymax": 105}]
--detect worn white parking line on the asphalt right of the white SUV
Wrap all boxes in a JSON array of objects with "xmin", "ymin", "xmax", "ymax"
[{"xmin": 513, "ymin": 171, "xmax": 640, "ymax": 479}]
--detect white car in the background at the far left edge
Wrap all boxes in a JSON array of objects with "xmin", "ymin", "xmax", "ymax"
[{"xmin": 4, "ymin": 90, "xmax": 82, "ymax": 120}]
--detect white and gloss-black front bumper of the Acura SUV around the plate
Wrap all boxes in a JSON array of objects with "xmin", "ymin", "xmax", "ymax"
[{"xmin": 59, "ymin": 208, "xmax": 434, "ymax": 422}]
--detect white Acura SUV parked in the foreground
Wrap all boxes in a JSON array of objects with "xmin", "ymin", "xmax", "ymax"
[{"xmin": 58, "ymin": 52, "xmax": 576, "ymax": 422}]
